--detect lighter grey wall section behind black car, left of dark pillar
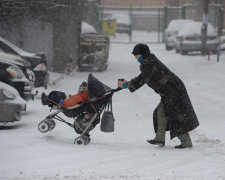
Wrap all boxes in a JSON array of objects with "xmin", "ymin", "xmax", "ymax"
[{"xmin": 0, "ymin": 10, "xmax": 53, "ymax": 64}]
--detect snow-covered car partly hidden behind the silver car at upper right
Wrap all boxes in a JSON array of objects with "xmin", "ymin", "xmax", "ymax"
[{"xmin": 165, "ymin": 19, "xmax": 193, "ymax": 50}]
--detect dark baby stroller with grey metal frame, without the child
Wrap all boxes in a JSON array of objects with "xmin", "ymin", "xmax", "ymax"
[{"xmin": 38, "ymin": 74, "xmax": 121, "ymax": 145}]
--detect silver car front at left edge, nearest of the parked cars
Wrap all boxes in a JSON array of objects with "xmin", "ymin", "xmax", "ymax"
[{"xmin": 0, "ymin": 82, "xmax": 26, "ymax": 123}]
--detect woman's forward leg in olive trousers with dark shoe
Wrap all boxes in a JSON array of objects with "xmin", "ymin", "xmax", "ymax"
[{"xmin": 147, "ymin": 103, "xmax": 167, "ymax": 147}]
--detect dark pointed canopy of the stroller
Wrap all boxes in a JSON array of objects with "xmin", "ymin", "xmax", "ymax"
[{"xmin": 88, "ymin": 74, "xmax": 112, "ymax": 100}]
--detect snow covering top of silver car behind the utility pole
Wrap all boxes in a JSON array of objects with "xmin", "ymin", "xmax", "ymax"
[{"xmin": 178, "ymin": 21, "xmax": 216, "ymax": 36}]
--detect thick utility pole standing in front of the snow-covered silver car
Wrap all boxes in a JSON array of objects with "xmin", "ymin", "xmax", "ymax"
[{"xmin": 201, "ymin": 0, "xmax": 209, "ymax": 56}]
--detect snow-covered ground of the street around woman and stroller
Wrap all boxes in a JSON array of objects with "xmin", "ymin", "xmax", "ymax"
[{"xmin": 0, "ymin": 44, "xmax": 225, "ymax": 180}]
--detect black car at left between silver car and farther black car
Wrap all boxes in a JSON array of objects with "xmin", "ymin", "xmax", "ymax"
[{"xmin": 0, "ymin": 54, "xmax": 33, "ymax": 100}]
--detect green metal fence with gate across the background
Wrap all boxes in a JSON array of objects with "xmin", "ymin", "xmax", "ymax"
[{"xmin": 97, "ymin": 4, "xmax": 224, "ymax": 43}]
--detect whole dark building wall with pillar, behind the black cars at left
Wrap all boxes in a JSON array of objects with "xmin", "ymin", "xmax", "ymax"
[{"xmin": 0, "ymin": 0, "xmax": 81, "ymax": 72}]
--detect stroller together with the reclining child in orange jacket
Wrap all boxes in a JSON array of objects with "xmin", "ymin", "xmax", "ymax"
[{"xmin": 38, "ymin": 74, "xmax": 120, "ymax": 145}]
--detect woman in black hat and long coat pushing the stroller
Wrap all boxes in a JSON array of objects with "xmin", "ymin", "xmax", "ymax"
[{"xmin": 118, "ymin": 44, "xmax": 199, "ymax": 148}]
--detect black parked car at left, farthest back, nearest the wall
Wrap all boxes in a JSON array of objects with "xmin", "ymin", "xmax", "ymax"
[{"xmin": 0, "ymin": 37, "xmax": 49, "ymax": 87}]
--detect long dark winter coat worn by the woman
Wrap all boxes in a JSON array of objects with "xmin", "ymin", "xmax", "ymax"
[{"xmin": 128, "ymin": 54, "xmax": 199, "ymax": 139}]
